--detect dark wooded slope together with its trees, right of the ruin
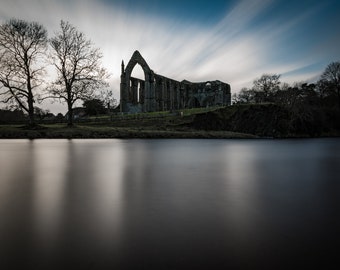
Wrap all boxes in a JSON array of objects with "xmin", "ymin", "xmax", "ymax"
[{"xmin": 193, "ymin": 65, "xmax": 340, "ymax": 137}]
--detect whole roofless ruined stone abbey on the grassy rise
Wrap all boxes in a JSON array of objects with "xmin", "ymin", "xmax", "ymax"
[{"xmin": 120, "ymin": 51, "xmax": 231, "ymax": 113}]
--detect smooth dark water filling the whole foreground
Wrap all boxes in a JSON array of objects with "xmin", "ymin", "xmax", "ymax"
[{"xmin": 0, "ymin": 139, "xmax": 340, "ymax": 269}]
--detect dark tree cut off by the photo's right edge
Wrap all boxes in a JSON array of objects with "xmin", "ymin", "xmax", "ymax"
[{"xmin": 319, "ymin": 62, "xmax": 340, "ymax": 108}]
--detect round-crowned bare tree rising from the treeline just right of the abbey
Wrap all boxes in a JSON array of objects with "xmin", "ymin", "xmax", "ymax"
[{"xmin": 253, "ymin": 74, "xmax": 281, "ymax": 103}]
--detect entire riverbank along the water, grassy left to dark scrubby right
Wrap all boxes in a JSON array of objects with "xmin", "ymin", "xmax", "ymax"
[{"xmin": 0, "ymin": 104, "xmax": 340, "ymax": 139}]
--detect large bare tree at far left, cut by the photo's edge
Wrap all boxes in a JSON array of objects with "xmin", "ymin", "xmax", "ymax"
[{"xmin": 0, "ymin": 19, "xmax": 47, "ymax": 126}]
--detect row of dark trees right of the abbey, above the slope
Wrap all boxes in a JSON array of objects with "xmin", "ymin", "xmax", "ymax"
[{"xmin": 233, "ymin": 62, "xmax": 340, "ymax": 110}]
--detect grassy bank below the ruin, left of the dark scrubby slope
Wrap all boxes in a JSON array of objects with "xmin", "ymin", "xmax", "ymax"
[{"xmin": 0, "ymin": 105, "xmax": 252, "ymax": 139}]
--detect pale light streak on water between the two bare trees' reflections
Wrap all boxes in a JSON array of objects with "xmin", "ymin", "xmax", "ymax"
[{"xmin": 29, "ymin": 140, "xmax": 70, "ymax": 249}]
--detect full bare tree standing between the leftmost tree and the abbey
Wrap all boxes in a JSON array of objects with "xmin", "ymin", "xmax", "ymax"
[{"xmin": 50, "ymin": 21, "xmax": 108, "ymax": 126}]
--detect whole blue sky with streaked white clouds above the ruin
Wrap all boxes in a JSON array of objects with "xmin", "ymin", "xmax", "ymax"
[{"xmin": 0, "ymin": 0, "xmax": 340, "ymax": 113}]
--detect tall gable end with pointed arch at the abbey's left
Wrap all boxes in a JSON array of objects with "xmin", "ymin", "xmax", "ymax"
[{"xmin": 120, "ymin": 51, "xmax": 155, "ymax": 112}]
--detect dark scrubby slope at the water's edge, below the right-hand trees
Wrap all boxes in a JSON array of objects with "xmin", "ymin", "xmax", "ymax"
[{"xmin": 191, "ymin": 104, "xmax": 340, "ymax": 138}]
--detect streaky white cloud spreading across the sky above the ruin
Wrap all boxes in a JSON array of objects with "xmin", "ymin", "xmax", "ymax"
[{"xmin": 0, "ymin": 0, "xmax": 338, "ymax": 112}]
